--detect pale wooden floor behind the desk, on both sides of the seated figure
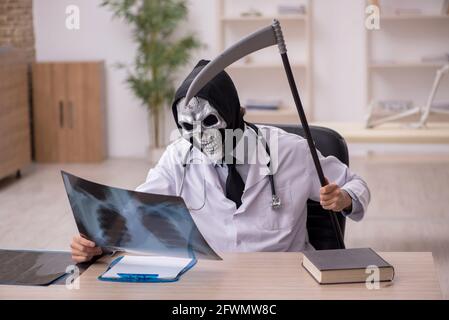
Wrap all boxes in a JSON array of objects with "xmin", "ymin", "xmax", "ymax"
[{"xmin": 0, "ymin": 156, "xmax": 449, "ymax": 299}]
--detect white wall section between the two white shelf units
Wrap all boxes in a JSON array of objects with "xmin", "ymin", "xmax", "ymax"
[{"xmin": 313, "ymin": 0, "xmax": 366, "ymax": 121}]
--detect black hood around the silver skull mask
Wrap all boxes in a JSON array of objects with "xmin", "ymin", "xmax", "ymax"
[{"xmin": 172, "ymin": 60, "xmax": 244, "ymax": 130}]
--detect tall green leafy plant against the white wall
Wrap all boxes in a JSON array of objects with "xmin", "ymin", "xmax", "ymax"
[{"xmin": 101, "ymin": 0, "xmax": 201, "ymax": 147}]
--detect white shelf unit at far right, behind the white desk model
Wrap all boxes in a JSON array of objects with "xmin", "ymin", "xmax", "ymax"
[{"xmin": 365, "ymin": 0, "xmax": 449, "ymax": 121}]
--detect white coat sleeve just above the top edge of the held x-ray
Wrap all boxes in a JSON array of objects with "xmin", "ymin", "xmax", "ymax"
[{"xmin": 136, "ymin": 148, "xmax": 176, "ymax": 195}]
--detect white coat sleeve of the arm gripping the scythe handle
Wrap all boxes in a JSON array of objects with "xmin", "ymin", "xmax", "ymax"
[{"xmin": 307, "ymin": 151, "xmax": 371, "ymax": 221}]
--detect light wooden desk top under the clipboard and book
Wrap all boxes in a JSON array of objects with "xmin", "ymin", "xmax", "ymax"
[{"xmin": 0, "ymin": 252, "xmax": 442, "ymax": 299}]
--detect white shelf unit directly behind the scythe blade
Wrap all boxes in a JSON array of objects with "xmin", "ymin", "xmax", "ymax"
[{"xmin": 216, "ymin": 0, "xmax": 313, "ymax": 124}]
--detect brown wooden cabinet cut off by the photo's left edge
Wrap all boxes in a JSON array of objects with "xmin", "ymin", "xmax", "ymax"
[{"xmin": 0, "ymin": 49, "xmax": 31, "ymax": 178}]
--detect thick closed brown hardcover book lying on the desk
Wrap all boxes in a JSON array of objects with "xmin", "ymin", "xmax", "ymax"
[{"xmin": 302, "ymin": 248, "xmax": 394, "ymax": 284}]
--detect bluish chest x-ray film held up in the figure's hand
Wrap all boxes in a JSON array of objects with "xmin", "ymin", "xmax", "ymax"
[{"xmin": 61, "ymin": 171, "xmax": 221, "ymax": 260}]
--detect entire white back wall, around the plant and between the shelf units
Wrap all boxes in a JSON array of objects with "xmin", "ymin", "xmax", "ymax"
[{"xmin": 34, "ymin": 0, "xmax": 444, "ymax": 157}]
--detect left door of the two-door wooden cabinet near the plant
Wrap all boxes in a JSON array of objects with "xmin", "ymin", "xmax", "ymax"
[{"xmin": 33, "ymin": 63, "xmax": 61, "ymax": 162}]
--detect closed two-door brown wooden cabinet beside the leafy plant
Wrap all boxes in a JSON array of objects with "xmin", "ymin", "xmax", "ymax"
[{"xmin": 33, "ymin": 62, "xmax": 106, "ymax": 162}]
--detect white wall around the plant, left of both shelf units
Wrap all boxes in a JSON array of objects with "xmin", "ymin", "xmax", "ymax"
[{"xmin": 33, "ymin": 0, "xmax": 215, "ymax": 157}]
